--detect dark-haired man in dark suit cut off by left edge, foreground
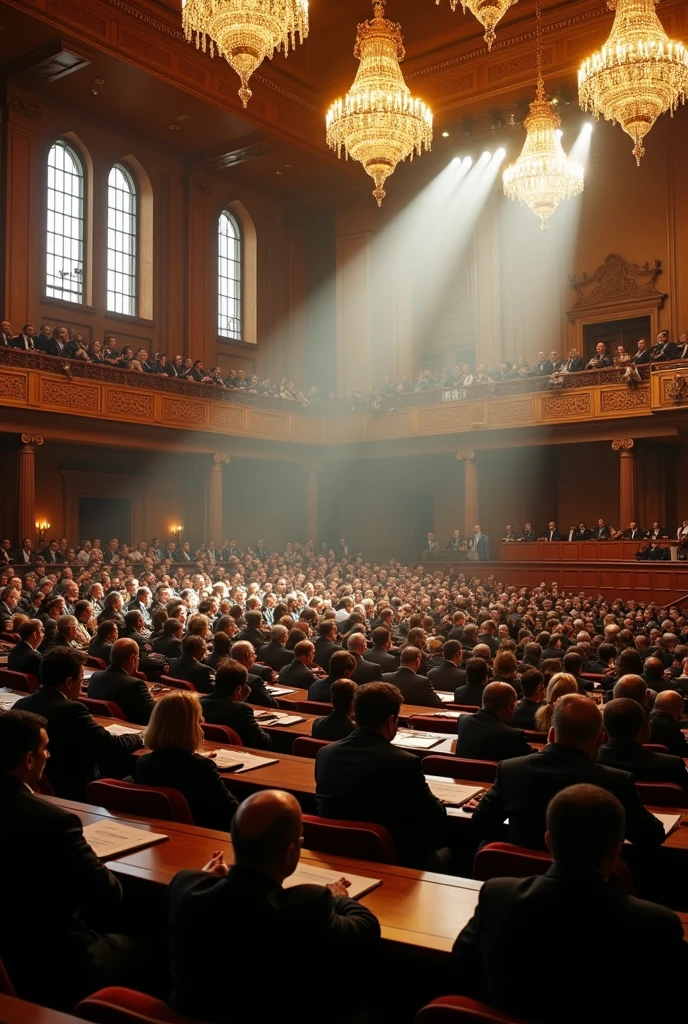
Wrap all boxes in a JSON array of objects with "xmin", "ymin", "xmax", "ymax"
[{"xmin": 0, "ymin": 709, "xmax": 148, "ymax": 1011}]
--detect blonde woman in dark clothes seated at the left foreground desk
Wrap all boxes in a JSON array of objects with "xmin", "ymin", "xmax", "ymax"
[{"xmin": 133, "ymin": 690, "xmax": 239, "ymax": 831}]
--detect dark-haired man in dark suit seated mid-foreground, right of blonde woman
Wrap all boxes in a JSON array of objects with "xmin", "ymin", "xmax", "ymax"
[{"xmin": 315, "ymin": 683, "xmax": 446, "ymax": 867}]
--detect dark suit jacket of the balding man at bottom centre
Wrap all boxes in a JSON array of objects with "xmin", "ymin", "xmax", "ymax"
[{"xmin": 168, "ymin": 865, "xmax": 380, "ymax": 1024}]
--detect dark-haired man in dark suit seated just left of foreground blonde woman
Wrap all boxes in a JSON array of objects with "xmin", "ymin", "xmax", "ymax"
[{"xmin": 14, "ymin": 647, "xmax": 143, "ymax": 800}]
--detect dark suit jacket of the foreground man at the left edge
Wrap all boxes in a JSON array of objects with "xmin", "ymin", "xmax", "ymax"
[{"xmin": 0, "ymin": 774, "xmax": 122, "ymax": 1010}]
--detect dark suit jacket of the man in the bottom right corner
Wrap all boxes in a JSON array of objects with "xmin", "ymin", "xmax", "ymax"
[{"xmin": 447, "ymin": 864, "xmax": 688, "ymax": 1024}]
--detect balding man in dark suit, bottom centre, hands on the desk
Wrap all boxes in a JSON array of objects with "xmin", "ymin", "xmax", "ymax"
[{"xmin": 168, "ymin": 790, "xmax": 380, "ymax": 1024}]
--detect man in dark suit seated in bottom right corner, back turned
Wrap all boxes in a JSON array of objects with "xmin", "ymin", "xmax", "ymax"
[{"xmin": 454, "ymin": 784, "xmax": 688, "ymax": 1024}]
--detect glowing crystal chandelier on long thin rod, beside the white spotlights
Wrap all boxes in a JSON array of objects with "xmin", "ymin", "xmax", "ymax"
[{"xmin": 504, "ymin": 0, "xmax": 584, "ymax": 230}]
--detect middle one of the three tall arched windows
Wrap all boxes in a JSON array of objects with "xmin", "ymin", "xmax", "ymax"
[{"xmin": 108, "ymin": 164, "xmax": 138, "ymax": 316}]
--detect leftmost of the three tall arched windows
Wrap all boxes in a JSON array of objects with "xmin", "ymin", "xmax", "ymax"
[{"xmin": 45, "ymin": 140, "xmax": 84, "ymax": 302}]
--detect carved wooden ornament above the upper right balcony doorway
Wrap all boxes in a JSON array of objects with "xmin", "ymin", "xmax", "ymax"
[{"xmin": 568, "ymin": 253, "xmax": 667, "ymax": 324}]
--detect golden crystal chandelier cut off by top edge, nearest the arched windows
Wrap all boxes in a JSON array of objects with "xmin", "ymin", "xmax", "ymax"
[{"xmin": 181, "ymin": 0, "xmax": 308, "ymax": 106}]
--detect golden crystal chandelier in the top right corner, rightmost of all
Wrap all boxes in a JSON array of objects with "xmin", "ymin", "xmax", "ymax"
[{"xmin": 578, "ymin": 0, "xmax": 688, "ymax": 164}]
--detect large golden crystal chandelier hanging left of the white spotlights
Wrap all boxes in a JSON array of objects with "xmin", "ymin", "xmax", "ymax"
[{"xmin": 327, "ymin": 0, "xmax": 432, "ymax": 206}]
